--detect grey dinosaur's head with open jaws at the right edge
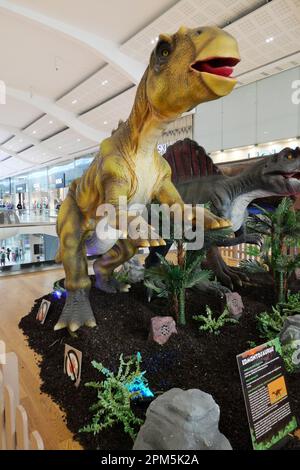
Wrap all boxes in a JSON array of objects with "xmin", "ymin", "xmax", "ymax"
[{"xmin": 258, "ymin": 147, "xmax": 300, "ymax": 196}]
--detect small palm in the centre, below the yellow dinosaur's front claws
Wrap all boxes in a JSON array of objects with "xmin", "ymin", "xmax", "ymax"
[{"xmin": 144, "ymin": 241, "xmax": 211, "ymax": 325}]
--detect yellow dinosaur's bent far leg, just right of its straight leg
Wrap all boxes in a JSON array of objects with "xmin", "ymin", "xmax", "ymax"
[{"xmin": 94, "ymin": 239, "xmax": 137, "ymax": 293}]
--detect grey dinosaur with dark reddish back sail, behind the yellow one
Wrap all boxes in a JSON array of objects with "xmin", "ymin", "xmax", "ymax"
[{"xmin": 145, "ymin": 143, "xmax": 300, "ymax": 289}]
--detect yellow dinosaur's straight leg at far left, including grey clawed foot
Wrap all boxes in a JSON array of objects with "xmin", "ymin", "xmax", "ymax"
[{"xmin": 54, "ymin": 193, "xmax": 96, "ymax": 331}]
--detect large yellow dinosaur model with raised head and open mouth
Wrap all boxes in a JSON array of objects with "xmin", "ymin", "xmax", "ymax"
[{"xmin": 55, "ymin": 23, "xmax": 240, "ymax": 331}]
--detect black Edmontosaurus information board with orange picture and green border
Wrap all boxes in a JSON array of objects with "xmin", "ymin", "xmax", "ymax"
[{"xmin": 237, "ymin": 338, "xmax": 298, "ymax": 450}]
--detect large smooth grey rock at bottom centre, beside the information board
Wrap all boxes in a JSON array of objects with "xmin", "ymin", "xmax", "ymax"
[{"xmin": 133, "ymin": 388, "xmax": 232, "ymax": 450}]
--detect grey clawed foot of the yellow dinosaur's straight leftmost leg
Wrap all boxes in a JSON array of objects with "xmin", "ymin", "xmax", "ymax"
[{"xmin": 54, "ymin": 289, "xmax": 96, "ymax": 332}]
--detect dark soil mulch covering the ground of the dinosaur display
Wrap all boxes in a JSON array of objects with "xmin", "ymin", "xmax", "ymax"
[{"xmin": 20, "ymin": 279, "xmax": 300, "ymax": 450}]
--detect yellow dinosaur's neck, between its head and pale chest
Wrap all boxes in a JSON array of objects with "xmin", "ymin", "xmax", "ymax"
[{"xmin": 126, "ymin": 70, "xmax": 171, "ymax": 160}]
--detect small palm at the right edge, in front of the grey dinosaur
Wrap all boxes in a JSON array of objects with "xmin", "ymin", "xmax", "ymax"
[{"xmin": 248, "ymin": 198, "xmax": 300, "ymax": 302}]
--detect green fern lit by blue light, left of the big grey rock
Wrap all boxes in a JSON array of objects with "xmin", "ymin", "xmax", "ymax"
[{"xmin": 79, "ymin": 353, "xmax": 147, "ymax": 440}]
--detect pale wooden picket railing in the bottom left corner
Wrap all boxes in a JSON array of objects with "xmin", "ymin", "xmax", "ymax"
[{"xmin": 0, "ymin": 346, "xmax": 44, "ymax": 450}]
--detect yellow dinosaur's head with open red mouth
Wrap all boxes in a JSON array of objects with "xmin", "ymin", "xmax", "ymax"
[{"xmin": 146, "ymin": 27, "xmax": 240, "ymax": 118}]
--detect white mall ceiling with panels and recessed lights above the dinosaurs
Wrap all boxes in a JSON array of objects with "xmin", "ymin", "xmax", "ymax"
[{"xmin": 0, "ymin": 0, "xmax": 300, "ymax": 178}]
